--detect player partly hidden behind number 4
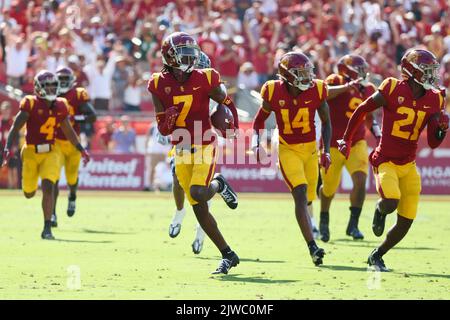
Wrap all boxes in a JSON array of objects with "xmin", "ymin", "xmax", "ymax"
[{"xmin": 52, "ymin": 67, "xmax": 97, "ymax": 227}]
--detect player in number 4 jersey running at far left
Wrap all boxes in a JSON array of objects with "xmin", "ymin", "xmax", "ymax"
[{"xmin": 0, "ymin": 70, "xmax": 89, "ymax": 240}]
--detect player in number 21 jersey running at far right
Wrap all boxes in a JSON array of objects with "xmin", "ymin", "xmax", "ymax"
[{"xmin": 338, "ymin": 49, "xmax": 449, "ymax": 271}]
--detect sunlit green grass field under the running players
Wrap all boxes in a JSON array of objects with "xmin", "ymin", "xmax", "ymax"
[{"xmin": 0, "ymin": 191, "xmax": 450, "ymax": 300}]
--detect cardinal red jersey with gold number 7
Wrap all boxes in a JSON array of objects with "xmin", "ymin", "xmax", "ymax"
[{"xmin": 147, "ymin": 69, "xmax": 220, "ymax": 145}]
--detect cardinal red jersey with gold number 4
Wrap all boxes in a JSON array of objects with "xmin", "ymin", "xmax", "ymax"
[{"xmin": 20, "ymin": 95, "xmax": 69, "ymax": 145}]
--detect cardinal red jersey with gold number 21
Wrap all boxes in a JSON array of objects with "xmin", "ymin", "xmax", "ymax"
[{"xmin": 371, "ymin": 78, "xmax": 444, "ymax": 167}]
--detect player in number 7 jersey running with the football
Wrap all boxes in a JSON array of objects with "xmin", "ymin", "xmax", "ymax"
[{"xmin": 148, "ymin": 32, "xmax": 239, "ymax": 274}]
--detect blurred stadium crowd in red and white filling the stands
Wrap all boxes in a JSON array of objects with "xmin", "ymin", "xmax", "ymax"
[{"xmin": 0, "ymin": 0, "xmax": 450, "ymax": 189}]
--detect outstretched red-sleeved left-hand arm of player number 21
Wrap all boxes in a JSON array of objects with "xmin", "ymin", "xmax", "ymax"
[{"xmin": 338, "ymin": 91, "xmax": 386, "ymax": 158}]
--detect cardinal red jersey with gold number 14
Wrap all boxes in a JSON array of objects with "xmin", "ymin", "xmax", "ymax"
[{"xmin": 261, "ymin": 79, "xmax": 328, "ymax": 144}]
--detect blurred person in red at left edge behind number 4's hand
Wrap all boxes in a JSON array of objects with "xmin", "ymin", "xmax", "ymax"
[{"xmin": 0, "ymin": 101, "xmax": 19, "ymax": 189}]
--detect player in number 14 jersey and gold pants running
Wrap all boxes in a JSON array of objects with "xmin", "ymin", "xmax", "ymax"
[{"xmin": 252, "ymin": 52, "xmax": 331, "ymax": 265}]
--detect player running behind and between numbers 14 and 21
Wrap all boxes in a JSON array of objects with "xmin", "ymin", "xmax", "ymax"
[{"xmin": 319, "ymin": 54, "xmax": 381, "ymax": 242}]
